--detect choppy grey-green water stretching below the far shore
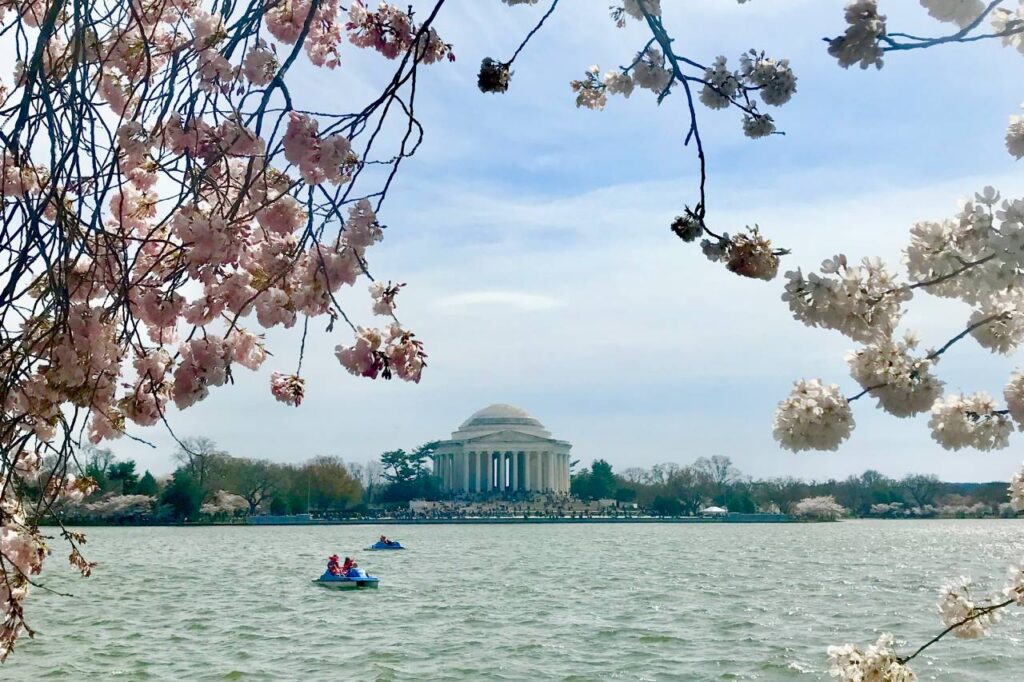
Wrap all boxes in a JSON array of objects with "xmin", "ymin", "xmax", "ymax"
[{"xmin": 8, "ymin": 520, "xmax": 1024, "ymax": 682}]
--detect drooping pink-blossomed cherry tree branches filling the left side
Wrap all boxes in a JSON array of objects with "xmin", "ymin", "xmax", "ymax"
[{"xmin": 0, "ymin": 0, "xmax": 454, "ymax": 659}]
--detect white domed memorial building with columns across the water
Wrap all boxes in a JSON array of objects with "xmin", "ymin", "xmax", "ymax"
[{"xmin": 433, "ymin": 404, "xmax": 572, "ymax": 495}]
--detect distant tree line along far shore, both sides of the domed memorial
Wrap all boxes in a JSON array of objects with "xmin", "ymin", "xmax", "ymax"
[{"xmin": 62, "ymin": 444, "xmax": 1013, "ymax": 522}]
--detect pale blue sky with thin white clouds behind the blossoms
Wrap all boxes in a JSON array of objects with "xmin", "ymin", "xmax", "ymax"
[{"xmin": 105, "ymin": 0, "xmax": 1024, "ymax": 481}]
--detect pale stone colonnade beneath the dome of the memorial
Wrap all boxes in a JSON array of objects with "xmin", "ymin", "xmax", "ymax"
[{"xmin": 433, "ymin": 451, "xmax": 569, "ymax": 493}]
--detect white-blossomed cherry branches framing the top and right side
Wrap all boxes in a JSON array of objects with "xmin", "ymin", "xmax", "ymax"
[{"xmin": 489, "ymin": 0, "xmax": 1024, "ymax": 682}]
